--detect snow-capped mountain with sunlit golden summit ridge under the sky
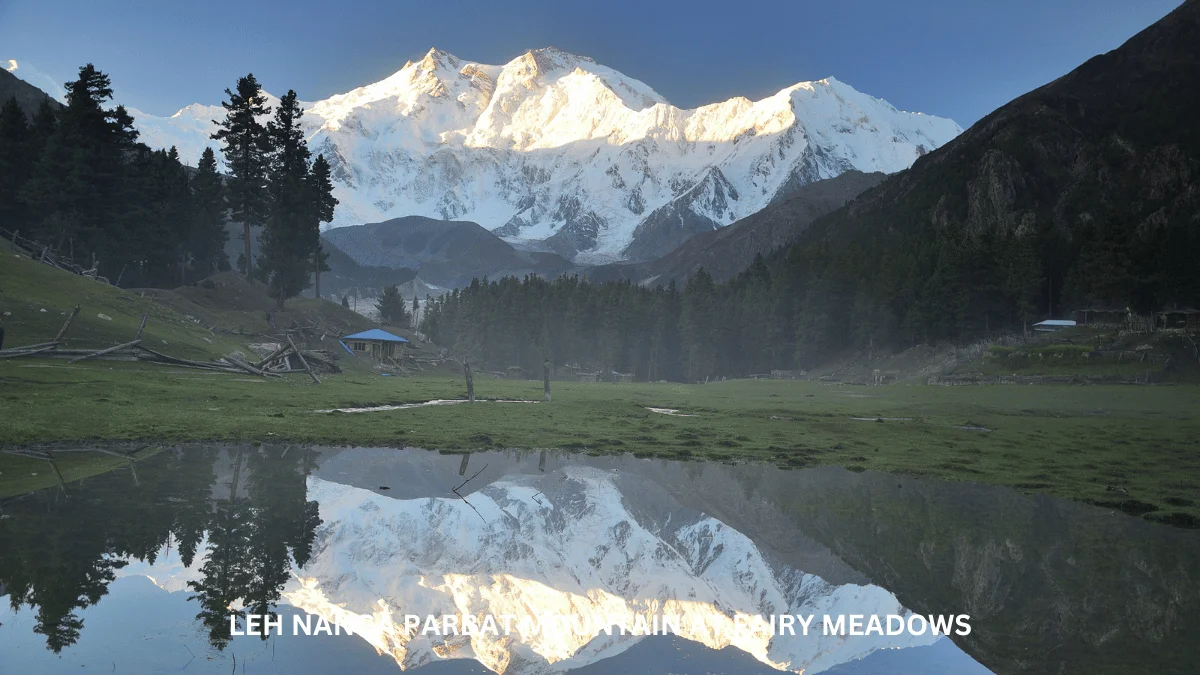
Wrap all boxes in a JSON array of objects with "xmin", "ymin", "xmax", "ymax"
[{"xmin": 133, "ymin": 48, "xmax": 961, "ymax": 263}]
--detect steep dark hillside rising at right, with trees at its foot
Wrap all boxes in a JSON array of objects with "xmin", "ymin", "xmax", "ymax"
[{"xmin": 788, "ymin": 0, "xmax": 1200, "ymax": 355}]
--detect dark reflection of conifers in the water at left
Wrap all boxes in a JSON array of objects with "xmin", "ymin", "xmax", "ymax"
[{"xmin": 0, "ymin": 447, "xmax": 320, "ymax": 652}]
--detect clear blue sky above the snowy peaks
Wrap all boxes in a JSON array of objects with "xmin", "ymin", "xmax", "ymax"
[{"xmin": 0, "ymin": 0, "xmax": 1180, "ymax": 126}]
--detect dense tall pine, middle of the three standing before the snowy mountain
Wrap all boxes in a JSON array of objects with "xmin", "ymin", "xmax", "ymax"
[{"xmin": 262, "ymin": 90, "xmax": 320, "ymax": 307}]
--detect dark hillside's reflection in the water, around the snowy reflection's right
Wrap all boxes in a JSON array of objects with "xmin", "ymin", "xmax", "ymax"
[{"xmin": 319, "ymin": 450, "xmax": 1200, "ymax": 675}]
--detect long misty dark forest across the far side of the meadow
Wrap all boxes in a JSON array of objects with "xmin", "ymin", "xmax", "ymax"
[{"xmin": 421, "ymin": 205, "xmax": 1200, "ymax": 382}]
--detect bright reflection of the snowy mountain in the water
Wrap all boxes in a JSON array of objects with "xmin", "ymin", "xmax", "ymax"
[{"xmin": 286, "ymin": 466, "xmax": 936, "ymax": 673}]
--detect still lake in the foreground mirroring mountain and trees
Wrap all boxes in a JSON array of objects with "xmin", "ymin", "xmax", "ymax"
[{"xmin": 0, "ymin": 446, "xmax": 1200, "ymax": 675}]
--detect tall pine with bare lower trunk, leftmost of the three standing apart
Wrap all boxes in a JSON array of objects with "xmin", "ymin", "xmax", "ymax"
[{"xmin": 212, "ymin": 73, "xmax": 271, "ymax": 281}]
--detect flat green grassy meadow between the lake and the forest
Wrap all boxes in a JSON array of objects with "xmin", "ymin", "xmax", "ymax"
[{"xmin": 0, "ymin": 359, "xmax": 1200, "ymax": 525}]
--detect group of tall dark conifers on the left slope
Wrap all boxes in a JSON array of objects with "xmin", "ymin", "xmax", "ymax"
[{"xmin": 0, "ymin": 64, "xmax": 337, "ymax": 305}]
